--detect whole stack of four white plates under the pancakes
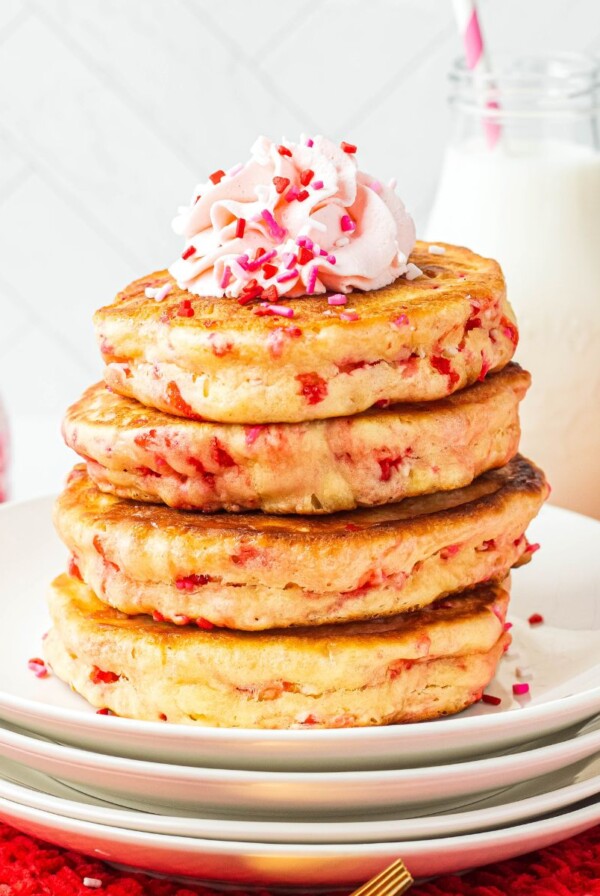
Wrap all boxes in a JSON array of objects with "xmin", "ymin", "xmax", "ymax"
[{"xmin": 0, "ymin": 499, "xmax": 600, "ymax": 886}]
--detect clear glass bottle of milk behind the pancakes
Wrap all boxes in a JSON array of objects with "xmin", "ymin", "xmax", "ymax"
[{"xmin": 426, "ymin": 54, "xmax": 600, "ymax": 517}]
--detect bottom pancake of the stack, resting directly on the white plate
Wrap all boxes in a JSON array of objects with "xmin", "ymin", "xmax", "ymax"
[{"xmin": 44, "ymin": 575, "xmax": 510, "ymax": 728}]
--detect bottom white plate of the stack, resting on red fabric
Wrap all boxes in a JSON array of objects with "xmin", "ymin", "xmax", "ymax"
[{"xmin": 0, "ymin": 798, "xmax": 600, "ymax": 886}]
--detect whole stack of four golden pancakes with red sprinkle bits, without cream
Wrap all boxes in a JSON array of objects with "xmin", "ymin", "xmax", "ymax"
[{"xmin": 45, "ymin": 244, "xmax": 548, "ymax": 728}]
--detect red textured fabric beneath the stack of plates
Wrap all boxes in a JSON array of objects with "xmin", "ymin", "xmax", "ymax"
[{"xmin": 0, "ymin": 824, "xmax": 600, "ymax": 896}]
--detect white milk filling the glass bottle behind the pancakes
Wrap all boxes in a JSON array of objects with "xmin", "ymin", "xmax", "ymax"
[{"xmin": 426, "ymin": 141, "xmax": 600, "ymax": 517}]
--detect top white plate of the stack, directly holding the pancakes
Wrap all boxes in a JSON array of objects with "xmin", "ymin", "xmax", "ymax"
[{"xmin": 0, "ymin": 498, "xmax": 600, "ymax": 770}]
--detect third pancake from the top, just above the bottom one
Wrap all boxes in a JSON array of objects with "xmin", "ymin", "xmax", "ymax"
[{"xmin": 55, "ymin": 457, "xmax": 548, "ymax": 630}]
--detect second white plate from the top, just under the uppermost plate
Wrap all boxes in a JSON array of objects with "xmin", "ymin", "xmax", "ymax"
[{"xmin": 0, "ymin": 720, "xmax": 600, "ymax": 820}]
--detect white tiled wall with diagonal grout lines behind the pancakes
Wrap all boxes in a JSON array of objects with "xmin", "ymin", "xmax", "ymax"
[{"xmin": 0, "ymin": 0, "xmax": 600, "ymax": 493}]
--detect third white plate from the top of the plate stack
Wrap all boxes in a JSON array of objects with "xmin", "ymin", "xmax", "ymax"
[{"xmin": 0, "ymin": 756, "xmax": 600, "ymax": 844}]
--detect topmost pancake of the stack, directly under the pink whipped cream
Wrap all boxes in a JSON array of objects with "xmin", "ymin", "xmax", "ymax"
[{"xmin": 94, "ymin": 243, "xmax": 518, "ymax": 424}]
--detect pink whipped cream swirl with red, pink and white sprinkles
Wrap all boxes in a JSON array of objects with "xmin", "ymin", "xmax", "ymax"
[{"xmin": 169, "ymin": 137, "xmax": 415, "ymax": 303}]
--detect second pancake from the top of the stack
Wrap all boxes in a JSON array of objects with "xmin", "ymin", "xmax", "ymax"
[{"xmin": 63, "ymin": 364, "xmax": 530, "ymax": 514}]
